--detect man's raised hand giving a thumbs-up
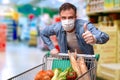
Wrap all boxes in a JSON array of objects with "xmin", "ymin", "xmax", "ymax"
[{"xmin": 82, "ymin": 23, "xmax": 96, "ymax": 45}]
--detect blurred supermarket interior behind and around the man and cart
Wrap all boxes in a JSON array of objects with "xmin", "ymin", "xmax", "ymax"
[{"xmin": 0, "ymin": 0, "xmax": 120, "ymax": 80}]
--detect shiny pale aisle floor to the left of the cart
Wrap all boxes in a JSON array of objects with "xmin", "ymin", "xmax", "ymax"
[{"xmin": 0, "ymin": 43, "xmax": 46, "ymax": 80}]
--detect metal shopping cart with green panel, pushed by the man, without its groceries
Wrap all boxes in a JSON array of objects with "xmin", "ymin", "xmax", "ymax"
[{"xmin": 8, "ymin": 52, "xmax": 99, "ymax": 80}]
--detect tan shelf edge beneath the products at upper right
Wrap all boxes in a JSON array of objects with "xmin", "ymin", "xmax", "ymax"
[{"xmin": 87, "ymin": 8, "xmax": 120, "ymax": 16}]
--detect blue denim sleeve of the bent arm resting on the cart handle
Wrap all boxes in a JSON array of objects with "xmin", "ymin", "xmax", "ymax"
[{"xmin": 40, "ymin": 25, "xmax": 55, "ymax": 50}]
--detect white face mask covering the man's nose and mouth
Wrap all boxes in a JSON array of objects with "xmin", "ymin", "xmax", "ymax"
[{"xmin": 61, "ymin": 19, "xmax": 75, "ymax": 31}]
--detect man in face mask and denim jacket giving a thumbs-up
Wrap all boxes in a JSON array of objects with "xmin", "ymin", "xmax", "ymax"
[{"xmin": 41, "ymin": 3, "xmax": 109, "ymax": 55}]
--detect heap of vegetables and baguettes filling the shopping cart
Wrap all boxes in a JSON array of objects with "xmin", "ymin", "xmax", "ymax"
[{"xmin": 34, "ymin": 51, "xmax": 90, "ymax": 80}]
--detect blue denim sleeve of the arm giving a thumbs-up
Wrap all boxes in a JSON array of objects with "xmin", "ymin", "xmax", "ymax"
[{"xmin": 87, "ymin": 23, "xmax": 109, "ymax": 44}]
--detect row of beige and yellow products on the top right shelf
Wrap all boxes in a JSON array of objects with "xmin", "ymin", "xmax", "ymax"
[{"xmin": 86, "ymin": 0, "xmax": 120, "ymax": 13}]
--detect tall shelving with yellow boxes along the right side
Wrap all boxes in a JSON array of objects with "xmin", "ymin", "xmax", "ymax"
[{"xmin": 86, "ymin": 0, "xmax": 120, "ymax": 80}]
